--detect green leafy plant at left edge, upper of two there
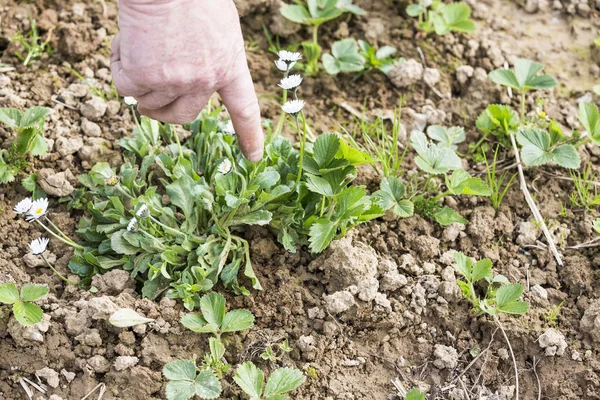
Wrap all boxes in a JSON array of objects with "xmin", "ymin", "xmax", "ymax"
[{"xmin": 0, "ymin": 107, "xmax": 50, "ymax": 183}]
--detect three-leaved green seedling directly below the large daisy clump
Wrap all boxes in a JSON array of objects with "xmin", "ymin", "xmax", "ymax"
[{"xmin": 181, "ymin": 292, "xmax": 254, "ymax": 339}]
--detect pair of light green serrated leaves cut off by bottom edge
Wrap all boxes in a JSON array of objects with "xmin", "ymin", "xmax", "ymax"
[{"xmin": 233, "ymin": 361, "xmax": 306, "ymax": 400}]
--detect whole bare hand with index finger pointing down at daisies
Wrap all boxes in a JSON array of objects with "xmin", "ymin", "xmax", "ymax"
[{"xmin": 111, "ymin": 0, "xmax": 264, "ymax": 161}]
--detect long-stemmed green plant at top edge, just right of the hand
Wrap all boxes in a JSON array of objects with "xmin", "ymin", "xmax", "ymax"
[{"xmin": 280, "ymin": 0, "xmax": 365, "ymax": 76}]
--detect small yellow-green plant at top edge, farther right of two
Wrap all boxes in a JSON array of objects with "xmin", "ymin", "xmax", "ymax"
[{"xmin": 406, "ymin": 0, "xmax": 477, "ymax": 35}]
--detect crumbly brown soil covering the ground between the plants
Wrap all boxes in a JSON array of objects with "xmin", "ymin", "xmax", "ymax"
[{"xmin": 0, "ymin": 0, "xmax": 600, "ymax": 400}]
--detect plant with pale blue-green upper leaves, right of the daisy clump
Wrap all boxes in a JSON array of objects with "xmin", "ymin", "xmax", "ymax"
[{"xmin": 410, "ymin": 125, "xmax": 492, "ymax": 226}]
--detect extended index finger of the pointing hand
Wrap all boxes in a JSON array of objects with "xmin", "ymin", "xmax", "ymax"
[{"xmin": 219, "ymin": 59, "xmax": 265, "ymax": 162}]
